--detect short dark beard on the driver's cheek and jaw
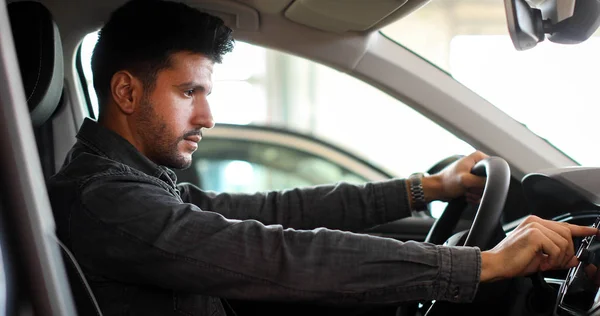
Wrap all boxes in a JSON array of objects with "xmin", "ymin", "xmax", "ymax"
[{"xmin": 138, "ymin": 97, "xmax": 192, "ymax": 169}]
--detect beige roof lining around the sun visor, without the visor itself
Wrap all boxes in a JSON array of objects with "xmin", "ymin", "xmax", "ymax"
[{"xmin": 17, "ymin": 0, "xmax": 428, "ymax": 71}]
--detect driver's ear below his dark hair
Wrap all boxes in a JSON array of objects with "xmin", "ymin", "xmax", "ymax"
[{"xmin": 110, "ymin": 70, "xmax": 143, "ymax": 115}]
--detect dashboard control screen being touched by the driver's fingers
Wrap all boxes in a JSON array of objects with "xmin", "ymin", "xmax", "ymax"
[{"xmin": 556, "ymin": 216, "xmax": 600, "ymax": 315}]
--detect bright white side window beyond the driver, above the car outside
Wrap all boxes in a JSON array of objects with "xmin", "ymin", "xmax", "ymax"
[{"xmin": 81, "ymin": 32, "xmax": 474, "ymax": 217}]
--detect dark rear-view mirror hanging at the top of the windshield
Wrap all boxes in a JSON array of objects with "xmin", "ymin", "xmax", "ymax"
[{"xmin": 504, "ymin": 0, "xmax": 600, "ymax": 50}]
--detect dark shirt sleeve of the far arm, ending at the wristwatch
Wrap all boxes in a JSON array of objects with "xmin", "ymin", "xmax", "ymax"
[{"xmin": 178, "ymin": 180, "xmax": 411, "ymax": 231}]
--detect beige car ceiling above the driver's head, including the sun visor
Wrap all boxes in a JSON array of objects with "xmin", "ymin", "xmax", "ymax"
[{"xmin": 8, "ymin": 0, "xmax": 429, "ymax": 71}]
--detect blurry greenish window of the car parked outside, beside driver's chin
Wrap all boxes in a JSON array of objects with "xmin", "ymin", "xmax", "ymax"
[{"xmin": 176, "ymin": 136, "xmax": 370, "ymax": 193}]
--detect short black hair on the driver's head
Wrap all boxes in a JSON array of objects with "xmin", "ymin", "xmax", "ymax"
[{"xmin": 92, "ymin": 0, "xmax": 233, "ymax": 112}]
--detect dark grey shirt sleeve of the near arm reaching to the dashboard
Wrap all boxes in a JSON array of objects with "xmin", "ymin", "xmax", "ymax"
[{"xmin": 75, "ymin": 176, "xmax": 481, "ymax": 304}]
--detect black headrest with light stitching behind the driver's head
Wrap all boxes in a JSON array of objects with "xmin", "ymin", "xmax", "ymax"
[{"xmin": 7, "ymin": 1, "xmax": 64, "ymax": 127}]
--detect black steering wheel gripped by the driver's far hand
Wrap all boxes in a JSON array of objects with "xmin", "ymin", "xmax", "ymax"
[{"xmin": 425, "ymin": 157, "xmax": 510, "ymax": 249}]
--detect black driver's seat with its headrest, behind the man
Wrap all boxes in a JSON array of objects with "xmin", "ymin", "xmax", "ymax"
[{"xmin": 7, "ymin": 1, "xmax": 102, "ymax": 315}]
